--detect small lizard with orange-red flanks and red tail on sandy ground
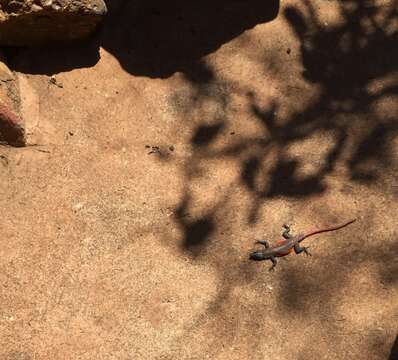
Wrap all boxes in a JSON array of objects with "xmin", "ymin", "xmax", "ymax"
[{"xmin": 250, "ymin": 219, "xmax": 356, "ymax": 271}]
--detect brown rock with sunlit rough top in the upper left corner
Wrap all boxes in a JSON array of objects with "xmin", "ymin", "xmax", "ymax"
[{"xmin": 0, "ymin": 0, "xmax": 107, "ymax": 46}]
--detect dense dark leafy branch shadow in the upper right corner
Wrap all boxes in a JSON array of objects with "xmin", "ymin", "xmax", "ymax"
[{"xmin": 236, "ymin": 0, "xmax": 398, "ymax": 223}]
